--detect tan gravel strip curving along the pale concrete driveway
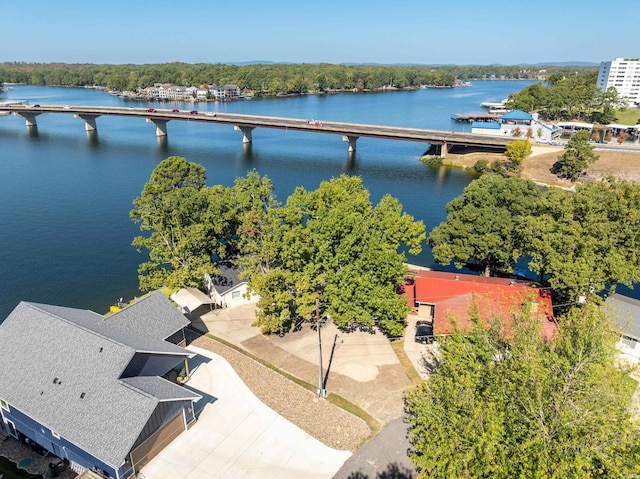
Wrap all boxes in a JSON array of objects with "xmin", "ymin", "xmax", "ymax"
[{"xmin": 191, "ymin": 336, "xmax": 371, "ymax": 451}]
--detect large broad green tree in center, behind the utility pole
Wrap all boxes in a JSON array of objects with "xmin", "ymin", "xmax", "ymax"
[{"xmin": 236, "ymin": 176, "xmax": 425, "ymax": 335}]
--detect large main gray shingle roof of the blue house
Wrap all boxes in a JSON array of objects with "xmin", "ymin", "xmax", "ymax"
[{"xmin": 0, "ymin": 299, "xmax": 198, "ymax": 468}]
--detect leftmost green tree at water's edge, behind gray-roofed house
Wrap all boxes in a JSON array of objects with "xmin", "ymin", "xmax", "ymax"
[{"xmin": 130, "ymin": 156, "xmax": 231, "ymax": 291}]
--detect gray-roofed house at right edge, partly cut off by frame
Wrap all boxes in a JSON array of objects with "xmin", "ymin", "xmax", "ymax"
[{"xmin": 604, "ymin": 293, "xmax": 640, "ymax": 363}]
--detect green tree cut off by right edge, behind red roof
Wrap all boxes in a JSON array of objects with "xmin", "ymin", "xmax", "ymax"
[{"xmin": 519, "ymin": 179, "xmax": 640, "ymax": 302}]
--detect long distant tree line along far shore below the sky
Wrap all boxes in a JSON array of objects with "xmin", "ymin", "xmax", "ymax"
[{"xmin": 0, "ymin": 62, "xmax": 589, "ymax": 95}]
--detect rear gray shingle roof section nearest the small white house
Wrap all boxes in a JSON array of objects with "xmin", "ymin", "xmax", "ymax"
[{"xmin": 101, "ymin": 291, "xmax": 189, "ymax": 339}]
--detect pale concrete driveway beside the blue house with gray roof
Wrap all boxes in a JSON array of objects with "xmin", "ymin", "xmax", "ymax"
[{"xmin": 142, "ymin": 346, "xmax": 351, "ymax": 479}]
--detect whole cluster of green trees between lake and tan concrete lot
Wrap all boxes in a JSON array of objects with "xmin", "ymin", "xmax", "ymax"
[{"xmin": 131, "ymin": 157, "xmax": 426, "ymax": 336}]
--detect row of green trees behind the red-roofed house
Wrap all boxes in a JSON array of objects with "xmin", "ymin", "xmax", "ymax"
[{"xmin": 428, "ymin": 174, "xmax": 640, "ymax": 303}]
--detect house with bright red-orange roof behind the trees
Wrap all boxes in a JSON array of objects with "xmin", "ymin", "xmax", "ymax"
[{"xmin": 404, "ymin": 270, "xmax": 556, "ymax": 338}]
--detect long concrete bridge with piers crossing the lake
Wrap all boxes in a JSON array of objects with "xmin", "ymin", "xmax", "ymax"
[{"xmin": 0, "ymin": 104, "xmax": 516, "ymax": 157}]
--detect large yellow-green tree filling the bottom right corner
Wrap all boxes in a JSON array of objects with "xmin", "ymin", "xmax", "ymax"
[{"xmin": 406, "ymin": 304, "xmax": 640, "ymax": 479}]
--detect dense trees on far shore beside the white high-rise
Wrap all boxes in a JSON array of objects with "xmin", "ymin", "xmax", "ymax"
[{"xmin": 506, "ymin": 71, "xmax": 627, "ymax": 124}]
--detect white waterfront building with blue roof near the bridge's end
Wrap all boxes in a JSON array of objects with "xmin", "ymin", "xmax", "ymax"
[{"xmin": 471, "ymin": 110, "xmax": 560, "ymax": 141}]
